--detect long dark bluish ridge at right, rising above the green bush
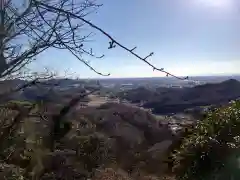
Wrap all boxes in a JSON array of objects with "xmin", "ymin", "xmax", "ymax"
[{"xmin": 119, "ymin": 79, "xmax": 240, "ymax": 114}]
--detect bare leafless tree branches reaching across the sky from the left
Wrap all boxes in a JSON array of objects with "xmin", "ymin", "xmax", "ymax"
[{"xmin": 0, "ymin": 0, "xmax": 188, "ymax": 80}]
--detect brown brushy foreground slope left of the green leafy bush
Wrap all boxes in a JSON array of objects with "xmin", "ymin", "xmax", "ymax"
[{"xmin": 0, "ymin": 101, "xmax": 176, "ymax": 180}]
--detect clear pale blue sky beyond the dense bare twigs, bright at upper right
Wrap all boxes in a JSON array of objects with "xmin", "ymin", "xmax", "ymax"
[{"xmin": 28, "ymin": 0, "xmax": 240, "ymax": 78}]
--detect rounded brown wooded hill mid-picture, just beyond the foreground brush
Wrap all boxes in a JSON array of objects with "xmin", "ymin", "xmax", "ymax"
[{"xmin": 80, "ymin": 103, "xmax": 173, "ymax": 144}]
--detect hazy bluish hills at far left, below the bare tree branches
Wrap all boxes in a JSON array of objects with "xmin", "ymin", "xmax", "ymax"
[{"xmin": 0, "ymin": 79, "xmax": 88, "ymax": 102}]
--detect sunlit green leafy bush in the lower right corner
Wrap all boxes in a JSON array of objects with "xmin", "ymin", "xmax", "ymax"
[{"xmin": 172, "ymin": 101, "xmax": 240, "ymax": 180}]
